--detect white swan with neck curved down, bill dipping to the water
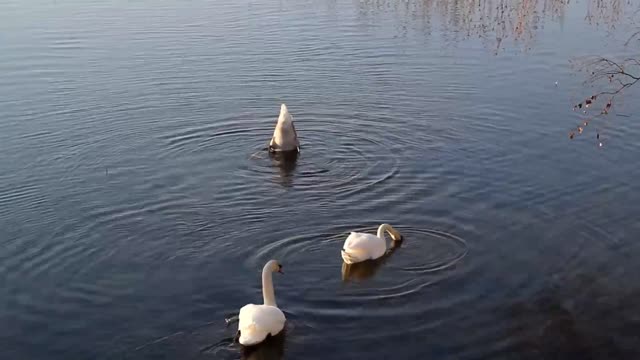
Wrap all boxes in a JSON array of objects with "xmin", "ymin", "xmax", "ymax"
[{"xmin": 342, "ymin": 224, "xmax": 402, "ymax": 264}]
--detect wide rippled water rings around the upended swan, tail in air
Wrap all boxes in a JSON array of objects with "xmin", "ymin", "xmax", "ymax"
[{"xmin": 161, "ymin": 112, "xmax": 420, "ymax": 197}]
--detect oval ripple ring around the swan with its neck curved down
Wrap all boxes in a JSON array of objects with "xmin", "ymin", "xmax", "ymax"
[{"xmin": 247, "ymin": 226, "xmax": 468, "ymax": 301}]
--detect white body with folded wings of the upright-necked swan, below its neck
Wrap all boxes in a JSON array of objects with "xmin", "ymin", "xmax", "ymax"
[{"xmin": 238, "ymin": 304, "xmax": 286, "ymax": 346}]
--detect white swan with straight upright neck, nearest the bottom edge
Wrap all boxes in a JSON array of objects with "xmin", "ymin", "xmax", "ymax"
[{"xmin": 238, "ymin": 260, "xmax": 286, "ymax": 346}]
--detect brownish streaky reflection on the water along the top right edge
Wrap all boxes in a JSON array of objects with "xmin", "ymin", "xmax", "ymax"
[{"xmin": 358, "ymin": 0, "xmax": 636, "ymax": 54}]
